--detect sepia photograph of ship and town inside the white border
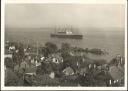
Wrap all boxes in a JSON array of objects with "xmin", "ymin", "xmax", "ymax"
[{"xmin": 1, "ymin": 0, "xmax": 127, "ymax": 88}]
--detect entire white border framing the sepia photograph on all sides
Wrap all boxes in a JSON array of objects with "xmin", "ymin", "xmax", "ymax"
[{"xmin": 1, "ymin": 0, "xmax": 127, "ymax": 90}]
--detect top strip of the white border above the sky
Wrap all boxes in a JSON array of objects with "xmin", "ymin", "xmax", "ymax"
[{"xmin": 5, "ymin": 0, "xmax": 126, "ymax": 4}]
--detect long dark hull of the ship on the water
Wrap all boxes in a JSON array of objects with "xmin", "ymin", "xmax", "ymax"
[{"xmin": 51, "ymin": 34, "xmax": 83, "ymax": 39}]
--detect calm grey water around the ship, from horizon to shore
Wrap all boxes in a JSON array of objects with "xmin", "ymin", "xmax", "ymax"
[{"xmin": 5, "ymin": 29, "xmax": 124, "ymax": 61}]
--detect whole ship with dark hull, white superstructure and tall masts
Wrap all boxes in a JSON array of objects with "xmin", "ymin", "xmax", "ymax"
[{"xmin": 51, "ymin": 28, "xmax": 83, "ymax": 39}]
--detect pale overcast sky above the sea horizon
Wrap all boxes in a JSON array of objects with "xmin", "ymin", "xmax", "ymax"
[{"xmin": 5, "ymin": 4, "xmax": 125, "ymax": 28}]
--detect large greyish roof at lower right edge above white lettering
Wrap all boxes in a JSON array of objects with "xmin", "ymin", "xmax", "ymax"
[{"xmin": 109, "ymin": 66, "xmax": 124, "ymax": 80}]
